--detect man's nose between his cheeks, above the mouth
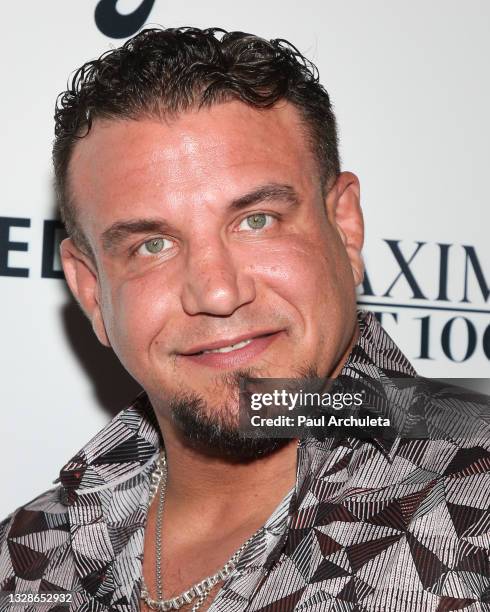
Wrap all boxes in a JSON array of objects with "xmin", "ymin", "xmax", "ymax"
[{"xmin": 182, "ymin": 237, "xmax": 255, "ymax": 316}]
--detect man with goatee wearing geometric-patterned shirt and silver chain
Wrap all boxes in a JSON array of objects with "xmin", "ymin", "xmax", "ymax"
[{"xmin": 0, "ymin": 28, "xmax": 490, "ymax": 612}]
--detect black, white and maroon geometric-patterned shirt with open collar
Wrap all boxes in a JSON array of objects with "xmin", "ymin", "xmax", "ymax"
[{"xmin": 0, "ymin": 312, "xmax": 490, "ymax": 612}]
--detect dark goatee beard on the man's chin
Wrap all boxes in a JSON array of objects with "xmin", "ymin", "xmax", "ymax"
[{"xmin": 165, "ymin": 366, "xmax": 318, "ymax": 463}]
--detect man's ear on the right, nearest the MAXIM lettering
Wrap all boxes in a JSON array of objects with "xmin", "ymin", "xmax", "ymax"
[{"xmin": 326, "ymin": 172, "xmax": 364, "ymax": 286}]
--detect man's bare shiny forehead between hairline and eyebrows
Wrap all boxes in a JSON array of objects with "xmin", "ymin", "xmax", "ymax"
[{"xmin": 69, "ymin": 102, "xmax": 317, "ymax": 232}]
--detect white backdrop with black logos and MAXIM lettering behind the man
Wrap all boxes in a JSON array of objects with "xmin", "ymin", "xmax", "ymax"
[{"xmin": 0, "ymin": 0, "xmax": 490, "ymax": 518}]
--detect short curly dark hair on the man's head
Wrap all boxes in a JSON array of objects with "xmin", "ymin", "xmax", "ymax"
[{"xmin": 53, "ymin": 27, "xmax": 340, "ymax": 257}]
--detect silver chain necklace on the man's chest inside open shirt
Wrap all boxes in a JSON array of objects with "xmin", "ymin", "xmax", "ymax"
[{"xmin": 141, "ymin": 452, "xmax": 264, "ymax": 612}]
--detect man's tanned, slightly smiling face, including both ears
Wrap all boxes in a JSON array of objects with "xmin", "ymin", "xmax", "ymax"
[{"xmin": 62, "ymin": 102, "xmax": 362, "ymax": 430}]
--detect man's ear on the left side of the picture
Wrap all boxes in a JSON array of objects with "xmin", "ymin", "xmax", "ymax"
[{"xmin": 60, "ymin": 238, "xmax": 110, "ymax": 346}]
